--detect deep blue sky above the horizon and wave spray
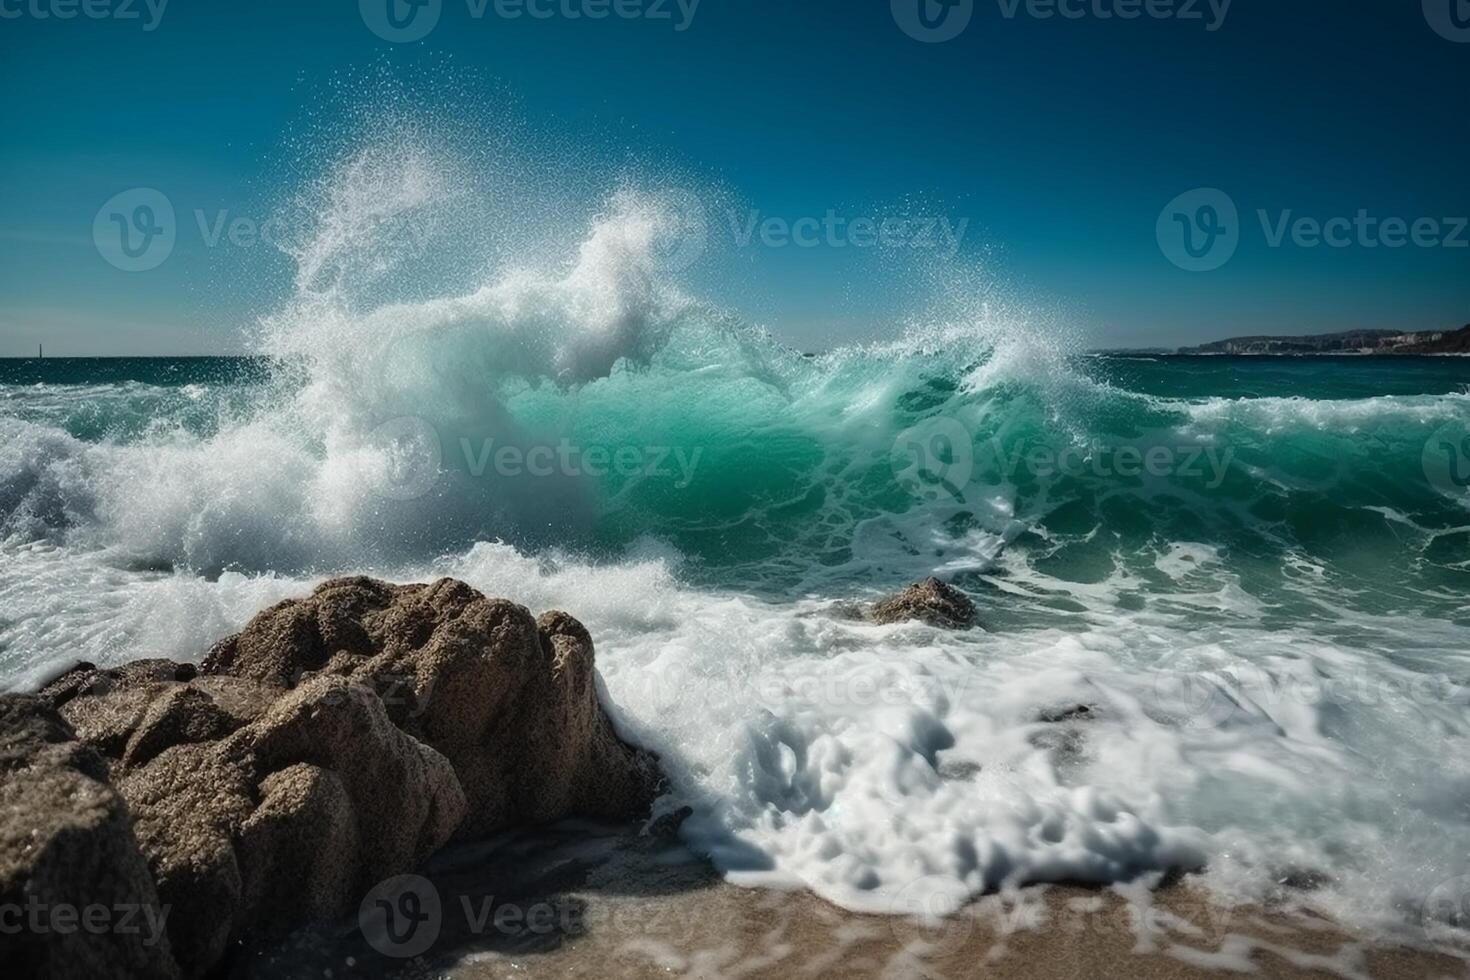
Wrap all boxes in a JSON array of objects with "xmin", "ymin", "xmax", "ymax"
[{"xmin": 0, "ymin": 0, "xmax": 1470, "ymax": 356}]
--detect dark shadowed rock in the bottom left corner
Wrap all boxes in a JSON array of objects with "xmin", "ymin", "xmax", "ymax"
[{"xmin": 0, "ymin": 695, "xmax": 178, "ymax": 980}]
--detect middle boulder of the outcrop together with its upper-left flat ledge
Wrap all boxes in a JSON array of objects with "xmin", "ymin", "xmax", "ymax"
[{"xmin": 43, "ymin": 661, "xmax": 465, "ymax": 976}]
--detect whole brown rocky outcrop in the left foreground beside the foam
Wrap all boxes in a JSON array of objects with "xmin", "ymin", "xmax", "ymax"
[{"xmin": 0, "ymin": 579, "xmax": 657, "ymax": 977}]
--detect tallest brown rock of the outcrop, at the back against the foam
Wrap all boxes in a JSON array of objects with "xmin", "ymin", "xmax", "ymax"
[{"xmin": 201, "ymin": 577, "xmax": 659, "ymax": 836}]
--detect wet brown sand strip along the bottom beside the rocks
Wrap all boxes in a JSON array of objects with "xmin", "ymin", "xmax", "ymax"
[{"xmin": 231, "ymin": 824, "xmax": 1470, "ymax": 980}]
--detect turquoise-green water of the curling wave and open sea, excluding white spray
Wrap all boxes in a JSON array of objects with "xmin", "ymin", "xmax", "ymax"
[{"xmin": 0, "ymin": 352, "xmax": 1470, "ymax": 623}]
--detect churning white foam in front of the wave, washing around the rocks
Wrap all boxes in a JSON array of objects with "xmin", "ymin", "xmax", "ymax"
[{"xmin": 0, "ymin": 544, "xmax": 1470, "ymax": 930}]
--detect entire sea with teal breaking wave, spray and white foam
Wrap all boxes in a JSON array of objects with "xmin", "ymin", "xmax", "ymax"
[{"xmin": 0, "ymin": 157, "xmax": 1470, "ymax": 934}]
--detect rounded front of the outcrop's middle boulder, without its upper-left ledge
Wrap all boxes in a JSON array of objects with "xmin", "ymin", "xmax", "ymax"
[{"xmin": 118, "ymin": 677, "xmax": 465, "ymax": 976}]
